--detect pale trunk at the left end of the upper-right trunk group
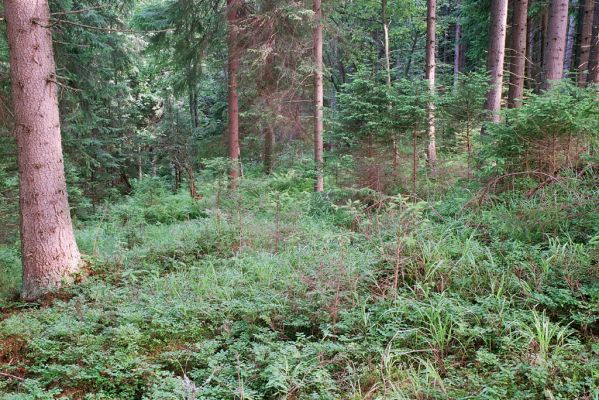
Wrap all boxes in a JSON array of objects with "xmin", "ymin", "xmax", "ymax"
[{"xmin": 486, "ymin": 0, "xmax": 508, "ymax": 122}]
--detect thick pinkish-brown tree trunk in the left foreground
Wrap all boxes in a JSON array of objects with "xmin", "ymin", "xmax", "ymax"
[{"xmin": 4, "ymin": 0, "xmax": 81, "ymax": 300}]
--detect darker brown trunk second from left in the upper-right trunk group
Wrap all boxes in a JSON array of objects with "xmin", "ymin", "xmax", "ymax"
[{"xmin": 508, "ymin": 0, "xmax": 528, "ymax": 108}]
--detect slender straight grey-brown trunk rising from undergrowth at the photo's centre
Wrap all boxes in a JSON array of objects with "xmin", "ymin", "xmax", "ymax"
[{"xmin": 314, "ymin": 0, "xmax": 324, "ymax": 192}]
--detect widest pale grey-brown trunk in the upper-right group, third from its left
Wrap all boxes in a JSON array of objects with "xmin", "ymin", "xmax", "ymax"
[{"xmin": 543, "ymin": 0, "xmax": 568, "ymax": 89}]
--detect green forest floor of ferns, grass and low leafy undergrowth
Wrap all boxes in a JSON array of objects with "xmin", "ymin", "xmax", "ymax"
[{"xmin": 0, "ymin": 163, "xmax": 599, "ymax": 400}]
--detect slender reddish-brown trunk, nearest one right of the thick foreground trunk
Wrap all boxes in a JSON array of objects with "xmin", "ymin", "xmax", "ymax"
[{"xmin": 227, "ymin": 0, "xmax": 241, "ymax": 189}]
